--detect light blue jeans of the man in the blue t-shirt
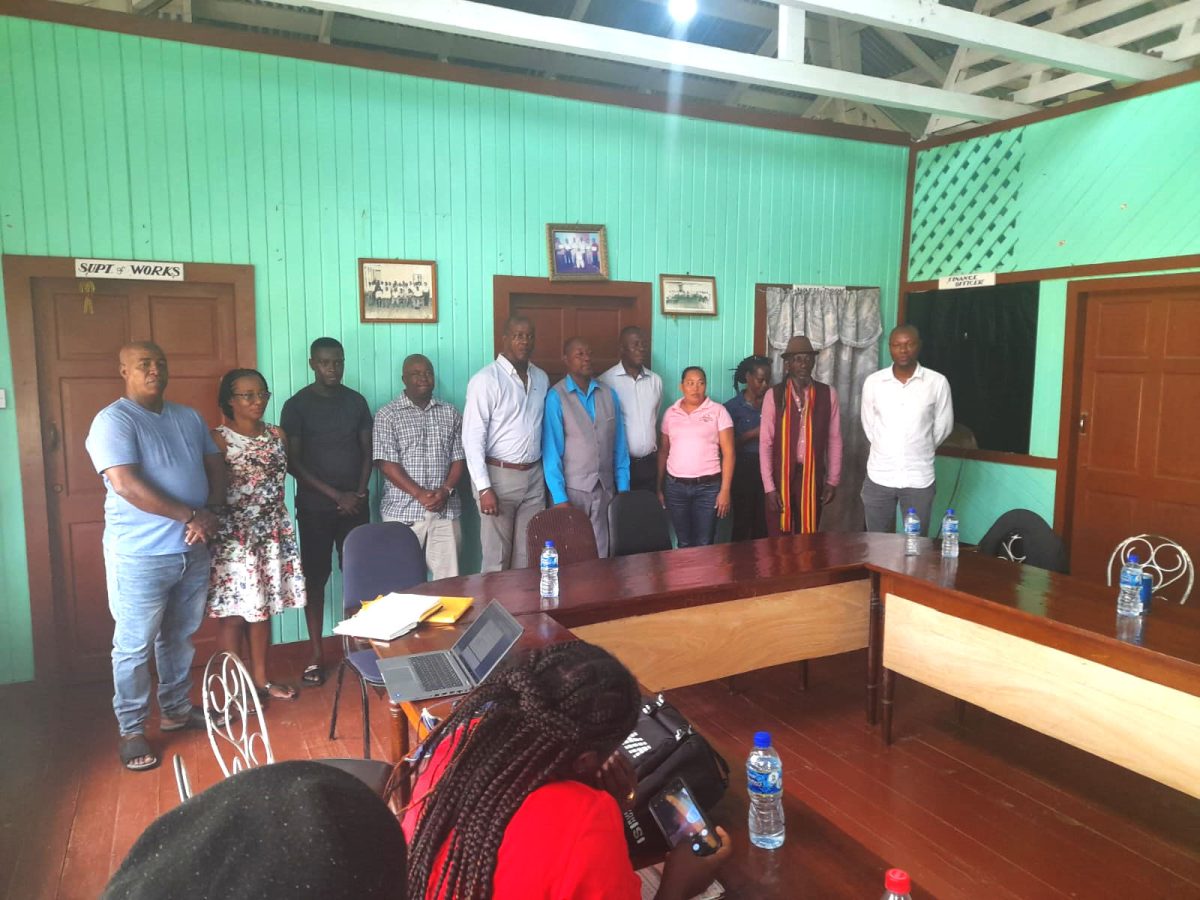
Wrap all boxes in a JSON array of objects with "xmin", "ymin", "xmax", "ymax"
[{"xmin": 104, "ymin": 544, "xmax": 211, "ymax": 734}]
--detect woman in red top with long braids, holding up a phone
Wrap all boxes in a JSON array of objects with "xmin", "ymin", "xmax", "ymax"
[{"xmin": 403, "ymin": 641, "xmax": 731, "ymax": 900}]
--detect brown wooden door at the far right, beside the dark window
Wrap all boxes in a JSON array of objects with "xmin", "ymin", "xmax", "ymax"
[{"xmin": 1069, "ymin": 277, "xmax": 1200, "ymax": 580}]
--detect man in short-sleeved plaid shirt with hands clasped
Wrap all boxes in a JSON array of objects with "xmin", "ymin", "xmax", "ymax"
[{"xmin": 373, "ymin": 354, "xmax": 466, "ymax": 580}]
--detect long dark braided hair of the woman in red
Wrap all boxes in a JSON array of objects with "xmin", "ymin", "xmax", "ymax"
[{"xmin": 394, "ymin": 641, "xmax": 641, "ymax": 900}]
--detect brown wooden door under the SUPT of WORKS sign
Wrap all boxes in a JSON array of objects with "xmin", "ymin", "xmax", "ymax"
[{"xmin": 26, "ymin": 278, "xmax": 246, "ymax": 682}]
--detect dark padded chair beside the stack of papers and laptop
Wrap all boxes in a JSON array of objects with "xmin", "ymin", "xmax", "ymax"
[{"xmin": 329, "ymin": 522, "xmax": 427, "ymax": 760}]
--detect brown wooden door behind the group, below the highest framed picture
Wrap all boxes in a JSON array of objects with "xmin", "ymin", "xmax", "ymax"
[{"xmin": 493, "ymin": 275, "xmax": 654, "ymax": 384}]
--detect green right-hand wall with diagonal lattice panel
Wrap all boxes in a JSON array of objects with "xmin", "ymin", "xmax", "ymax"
[{"xmin": 910, "ymin": 83, "xmax": 1200, "ymax": 540}]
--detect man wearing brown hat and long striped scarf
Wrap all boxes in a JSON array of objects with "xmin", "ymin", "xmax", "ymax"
[{"xmin": 758, "ymin": 335, "xmax": 841, "ymax": 535}]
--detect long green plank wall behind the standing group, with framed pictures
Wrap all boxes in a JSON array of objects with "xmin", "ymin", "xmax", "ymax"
[{"xmin": 0, "ymin": 18, "xmax": 905, "ymax": 683}]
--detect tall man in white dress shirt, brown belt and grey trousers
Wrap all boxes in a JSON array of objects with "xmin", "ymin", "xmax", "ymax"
[{"xmin": 462, "ymin": 316, "xmax": 550, "ymax": 572}]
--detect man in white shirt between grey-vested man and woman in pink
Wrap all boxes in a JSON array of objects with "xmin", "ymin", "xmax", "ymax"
[{"xmin": 600, "ymin": 325, "xmax": 662, "ymax": 492}]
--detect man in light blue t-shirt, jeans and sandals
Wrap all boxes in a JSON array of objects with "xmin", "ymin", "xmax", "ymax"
[{"xmin": 86, "ymin": 341, "xmax": 226, "ymax": 772}]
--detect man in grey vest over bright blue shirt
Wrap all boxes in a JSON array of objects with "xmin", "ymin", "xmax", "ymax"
[{"xmin": 541, "ymin": 337, "xmax": 629, "ymax": 558}]
